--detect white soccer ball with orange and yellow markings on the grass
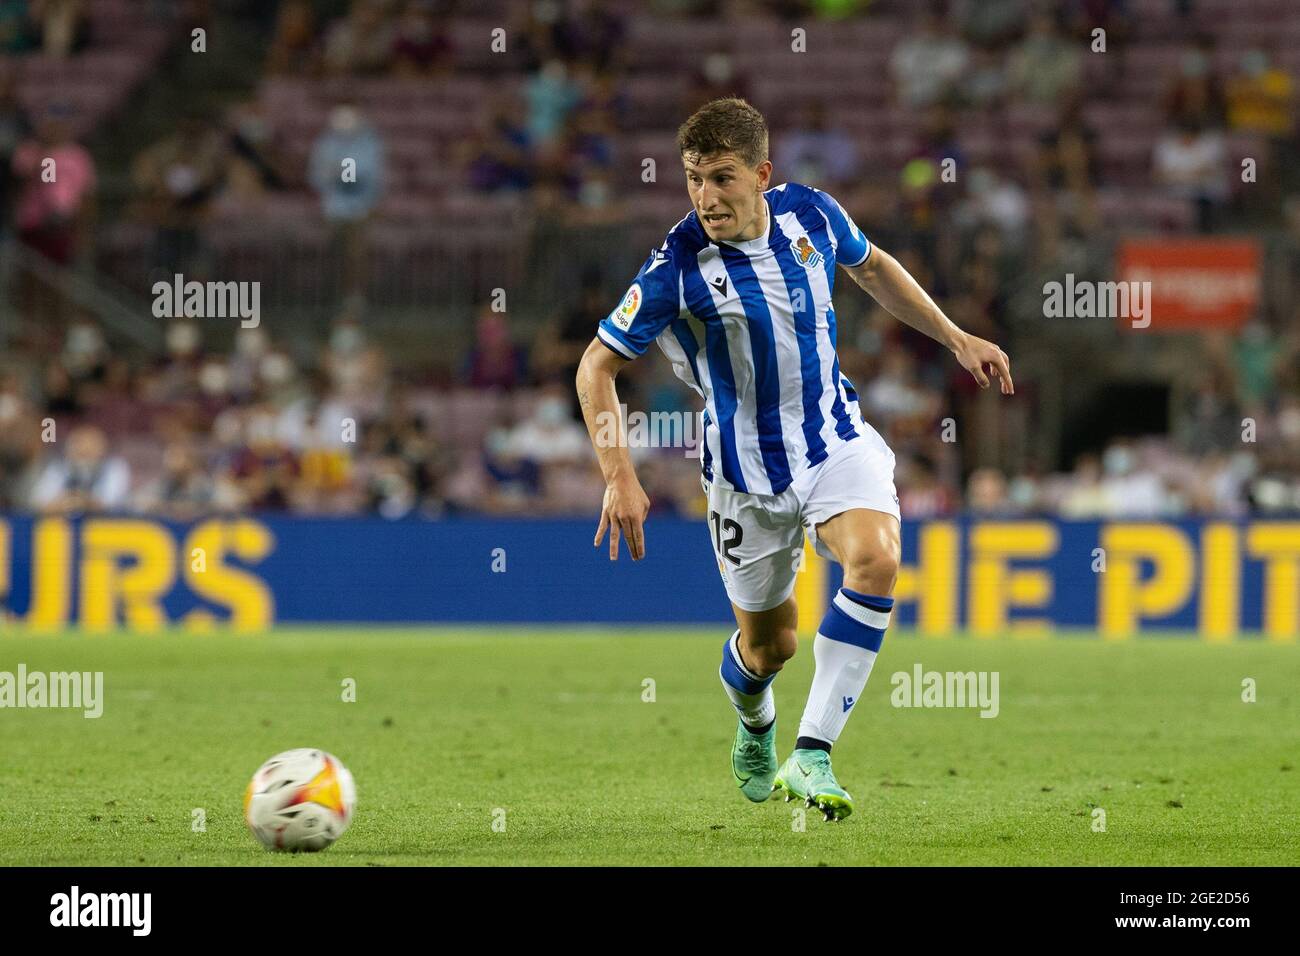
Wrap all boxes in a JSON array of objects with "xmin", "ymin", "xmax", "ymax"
[{"xmin": 244, "ymin": 747, "xmax": 356, "ymax": 852}]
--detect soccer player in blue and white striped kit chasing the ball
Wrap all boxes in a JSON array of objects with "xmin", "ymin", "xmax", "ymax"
[{"xmin": 577, "ymin": 99, "xmax": 1014, "ymax": 819}]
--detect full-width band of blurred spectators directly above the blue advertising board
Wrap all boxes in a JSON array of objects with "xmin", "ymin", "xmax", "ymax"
[{"xmin": 0, "ymin": 300, "xmax": 1300, "ymax": 520}]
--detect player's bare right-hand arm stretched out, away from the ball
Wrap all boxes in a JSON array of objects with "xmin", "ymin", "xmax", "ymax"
[{"xmin": 844, "ymin": 246, "xmax": 1015, "ymax": 395}]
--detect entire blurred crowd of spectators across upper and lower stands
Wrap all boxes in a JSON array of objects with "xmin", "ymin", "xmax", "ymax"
[{"xmin": 0, "ymin": 0, "xmax": 1300, "ymax": 519}]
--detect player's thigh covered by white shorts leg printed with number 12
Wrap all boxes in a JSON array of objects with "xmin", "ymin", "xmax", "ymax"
[{"xmin": 706, "ymin": 484, "xmax": 803, "ymax": 621}]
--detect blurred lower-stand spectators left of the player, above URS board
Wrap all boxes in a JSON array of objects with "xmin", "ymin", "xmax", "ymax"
[{"xmin": 0, "ymin": 313, "xmax": 698, "ymax": 520}]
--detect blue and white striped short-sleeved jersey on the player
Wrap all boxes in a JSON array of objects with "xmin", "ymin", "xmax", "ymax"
[{"xmin": 597, "ymin": 182, "xmax": 871, "ymax": 494}]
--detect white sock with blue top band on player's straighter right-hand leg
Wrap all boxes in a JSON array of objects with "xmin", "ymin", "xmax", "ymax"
[{"xmin": 796, "ymin": 588, "xmax": 893, "ymax": 750}]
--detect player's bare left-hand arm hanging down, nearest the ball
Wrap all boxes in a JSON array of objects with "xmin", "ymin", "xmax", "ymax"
[{"xmin": 577, "ymin": 338, "xmax": 650, "ymax": 561}]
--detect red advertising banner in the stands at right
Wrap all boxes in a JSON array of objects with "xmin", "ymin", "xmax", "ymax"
[{"xmin": 1115, "ymin": 238, "xmax": 1261, "ymax": 332}]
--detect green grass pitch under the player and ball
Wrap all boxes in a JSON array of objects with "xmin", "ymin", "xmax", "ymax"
[{"xmin": 0, "ymin": 628, "xmax": 1300, "ymax": 866}]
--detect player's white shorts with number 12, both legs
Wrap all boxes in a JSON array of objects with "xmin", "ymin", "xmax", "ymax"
[{"xmin": 701, "ymin": 425, "xmax": 900, "ymax": 611}]
